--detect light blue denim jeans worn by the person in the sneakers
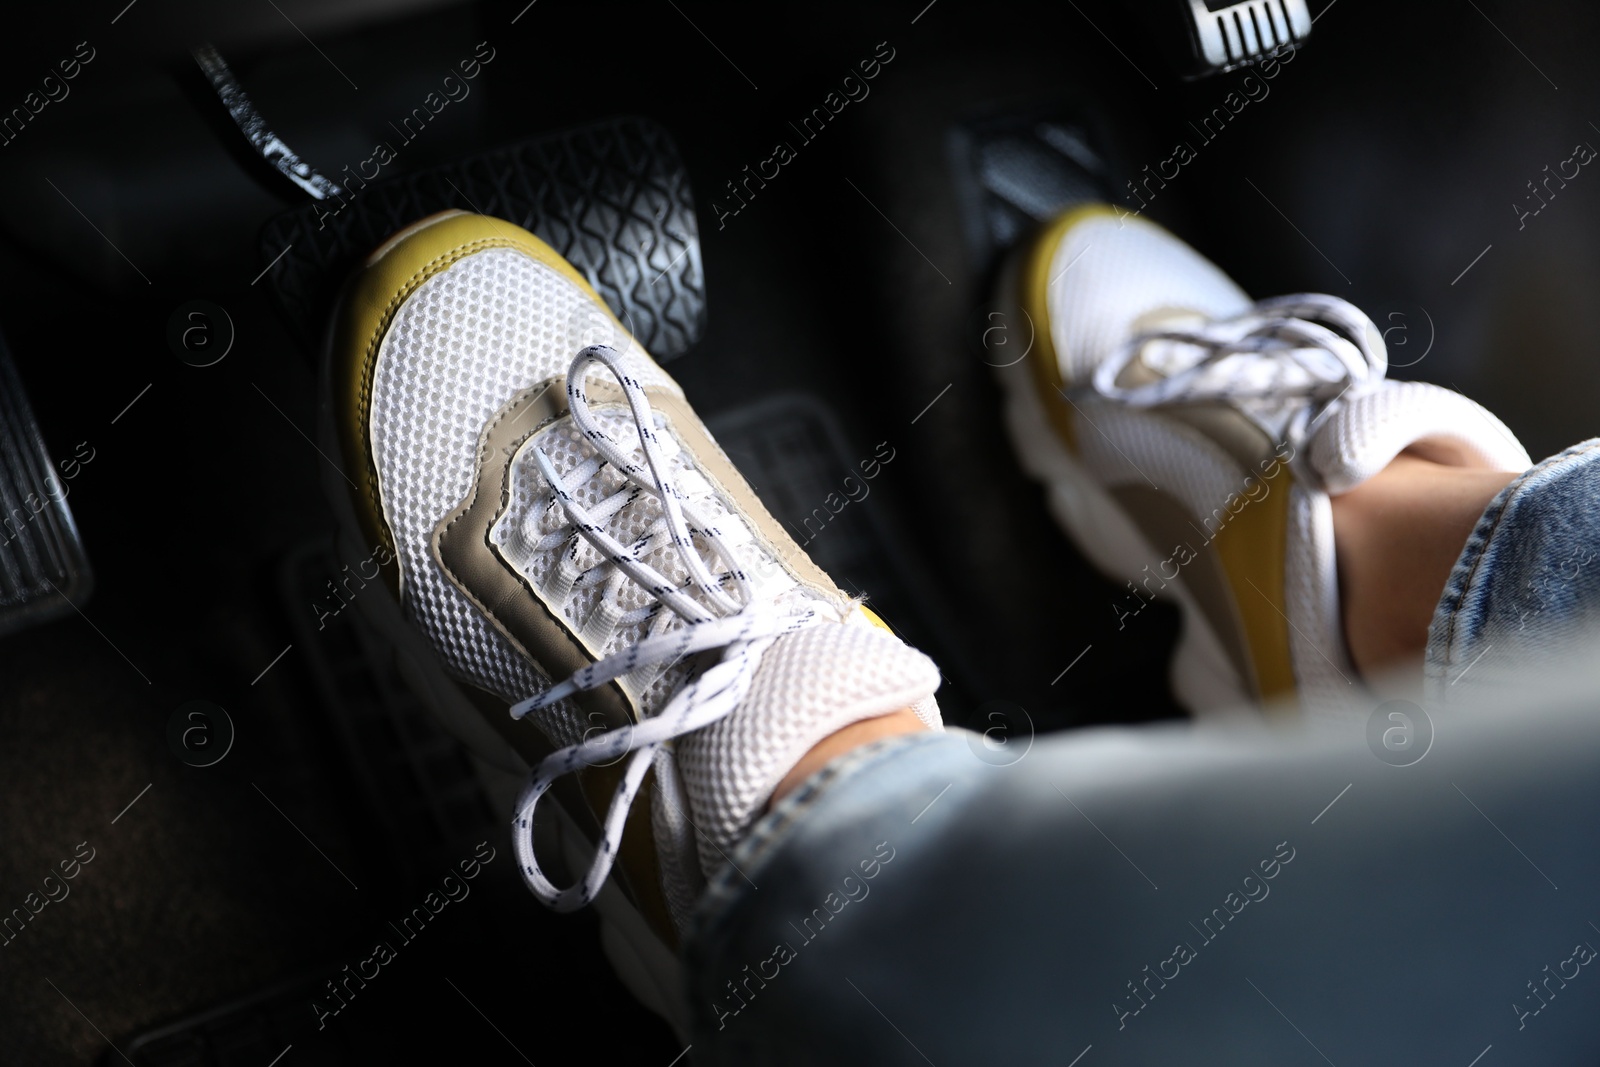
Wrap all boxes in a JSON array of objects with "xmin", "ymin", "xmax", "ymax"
[{"xmin": 685, "ymin": 442, "xmax": 1600, "ymax": 1067}]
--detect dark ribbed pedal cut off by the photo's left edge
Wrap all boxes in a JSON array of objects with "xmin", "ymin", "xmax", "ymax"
[{"xmin": 0, "ymin": 326, "xmax": 91, "ymax": 633}]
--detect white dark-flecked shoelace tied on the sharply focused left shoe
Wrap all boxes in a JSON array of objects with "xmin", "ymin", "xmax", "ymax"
[{"xmin": 510, "ymin": 346, "xmax": 816, "ymax": 912}]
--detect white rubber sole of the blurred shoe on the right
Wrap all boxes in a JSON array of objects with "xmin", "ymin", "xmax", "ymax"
[{"xmin": 994, "ymin": 272, "xmax": 1259, "ymax": 721}]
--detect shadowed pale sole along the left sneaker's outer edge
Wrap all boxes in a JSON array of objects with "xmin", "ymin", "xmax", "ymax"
[{"xmin": 317, "ymin": 216, "xmax": 688, "ymax": 1043}]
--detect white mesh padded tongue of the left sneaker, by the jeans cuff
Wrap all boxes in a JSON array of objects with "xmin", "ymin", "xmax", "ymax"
[{"xmin": 677, "ymin": 614, "xmax": 939, "ymax": 872}]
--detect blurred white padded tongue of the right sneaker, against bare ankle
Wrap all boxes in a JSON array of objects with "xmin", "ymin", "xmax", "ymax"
[{"xmin": 1309, "ymin": 381, "xmax": 1533, "ymax": 496}]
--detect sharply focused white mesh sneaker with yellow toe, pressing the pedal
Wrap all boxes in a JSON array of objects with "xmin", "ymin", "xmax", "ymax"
[{"xmin": 328, "ymin": 211, "xmax": 939, "ymax": 944}]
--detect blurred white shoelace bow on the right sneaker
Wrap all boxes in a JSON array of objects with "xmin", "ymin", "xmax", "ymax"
[{"xmin": 1093, "ymin": 293, "xmax": 1389, "ymax": 485}]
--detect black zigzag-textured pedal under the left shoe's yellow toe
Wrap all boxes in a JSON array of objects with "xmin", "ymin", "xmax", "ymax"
[{"xmin": 261, "ymin": 117, "xmax": 706, "ymax": 362}]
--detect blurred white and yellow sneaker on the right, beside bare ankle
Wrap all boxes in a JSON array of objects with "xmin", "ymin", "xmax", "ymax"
[{"xmin": 1002, "ymin": 205, "xmax": 1530, "ymax": 713}]
